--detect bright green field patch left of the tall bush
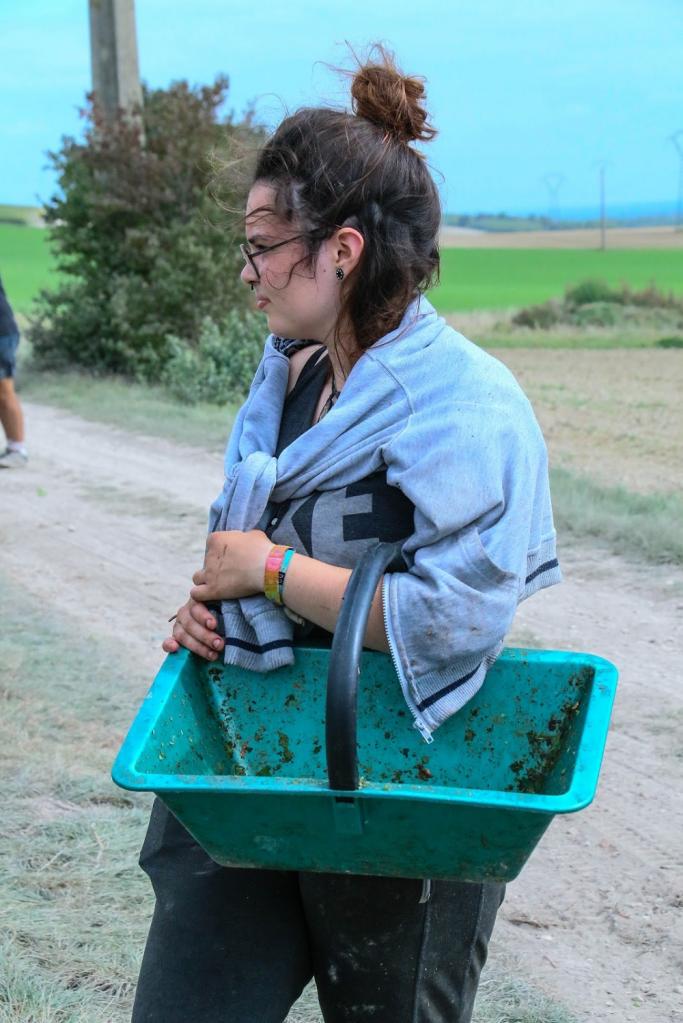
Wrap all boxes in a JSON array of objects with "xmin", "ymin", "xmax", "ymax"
[{"xmin": 0, "ymin": 224, "xmax": 54, "ymax": 315}]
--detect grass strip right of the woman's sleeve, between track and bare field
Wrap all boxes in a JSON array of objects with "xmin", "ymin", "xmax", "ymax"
[{"xmin": 551, "ymin": 469, "xmax": 683, "ymax": 565}]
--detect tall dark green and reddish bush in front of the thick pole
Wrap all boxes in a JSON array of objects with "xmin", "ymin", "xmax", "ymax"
[{"xmin": 29, "ymin": 78, "xmax": 260, "ymax": 381}]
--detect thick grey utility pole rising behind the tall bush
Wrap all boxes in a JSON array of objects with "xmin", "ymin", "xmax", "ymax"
[{"xmin": 88, "ymin": 0, "xmax": 142, "ymax": 118}]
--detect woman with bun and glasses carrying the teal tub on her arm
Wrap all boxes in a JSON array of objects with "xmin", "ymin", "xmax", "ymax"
[{"xmin": 133, "ymin": 51, "xmax": 559, "ymax": 1023}]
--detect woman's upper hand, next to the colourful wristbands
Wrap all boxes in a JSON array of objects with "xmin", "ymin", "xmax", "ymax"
[{"xmin": 190, "ymin": 529, "xmax": 273, "ymax": 602}]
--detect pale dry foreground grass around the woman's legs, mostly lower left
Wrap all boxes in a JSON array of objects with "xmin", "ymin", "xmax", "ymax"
[{"xmin": 0, "ymin": 580, "xmax": 575, "ymax": 1023}]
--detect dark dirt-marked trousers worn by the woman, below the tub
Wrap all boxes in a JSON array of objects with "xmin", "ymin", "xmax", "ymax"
[{"xmin": 133, "ymin": 800, "xmax": 504, "ymax": 1023}]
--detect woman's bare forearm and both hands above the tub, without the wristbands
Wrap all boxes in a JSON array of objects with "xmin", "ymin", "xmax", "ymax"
[{"xmin": 163, "ymin": 530, "xmax": 389, "ymax": 660}]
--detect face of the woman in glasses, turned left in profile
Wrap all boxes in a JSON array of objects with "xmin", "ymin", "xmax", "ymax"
[{"xmin": 240, "ymin": 181, "xmax": 340, "ymax": 341}]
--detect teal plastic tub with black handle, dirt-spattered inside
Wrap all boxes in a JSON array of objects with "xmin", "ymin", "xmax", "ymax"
[{"xmin": 112, "ymin": 545, "xmax": 617, "ymax": 881}]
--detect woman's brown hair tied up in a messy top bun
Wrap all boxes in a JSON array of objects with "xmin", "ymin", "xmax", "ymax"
[{"xmin": 249, "ymin": 47, "xmax": 441, "ymax": 354}]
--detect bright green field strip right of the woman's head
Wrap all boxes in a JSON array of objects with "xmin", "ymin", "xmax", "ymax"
[{"xmin": 429, "ymin": 248, "xmax": 683, "ymax": 312}]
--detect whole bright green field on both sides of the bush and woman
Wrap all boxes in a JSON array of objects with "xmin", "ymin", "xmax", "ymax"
[{"xmin": 0, "ymin": 224, "xmax": 683, "ymax": 314}]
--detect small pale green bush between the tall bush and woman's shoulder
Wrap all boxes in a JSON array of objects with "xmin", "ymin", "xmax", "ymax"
[{"xmin": 162, "ymin": 311, "xmax": 268, "ymax": 405}]
